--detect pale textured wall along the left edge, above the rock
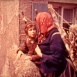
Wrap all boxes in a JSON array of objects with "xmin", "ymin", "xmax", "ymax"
[{"xmin": 0, "ymin": 0, "xmax": 19, "ymax": 76}]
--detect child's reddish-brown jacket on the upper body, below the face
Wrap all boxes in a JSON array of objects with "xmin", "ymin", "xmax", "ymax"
[{"xmin": 19, "ymin": 36, "xmax": 37, "ymax": 55}]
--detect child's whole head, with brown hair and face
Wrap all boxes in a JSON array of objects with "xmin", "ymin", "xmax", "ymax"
[{"xmin": 25, "ymin": 22, "xmax": 37, "ymax": 38}]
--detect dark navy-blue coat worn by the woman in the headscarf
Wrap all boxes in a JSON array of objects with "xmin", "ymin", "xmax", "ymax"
[{"xmin": 38, "ymin": 28, "xmax": 66, "ymax": 74}]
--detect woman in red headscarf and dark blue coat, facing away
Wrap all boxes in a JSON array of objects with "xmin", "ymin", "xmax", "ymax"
[{"xmin": 35, "ymin": 12, "xmax": 66, "ymax": 77}]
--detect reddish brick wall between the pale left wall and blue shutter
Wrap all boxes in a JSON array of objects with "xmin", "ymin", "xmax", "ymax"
[{"xmin": 19, "ymin": 0, "xmax": 32, "ymax": 43}]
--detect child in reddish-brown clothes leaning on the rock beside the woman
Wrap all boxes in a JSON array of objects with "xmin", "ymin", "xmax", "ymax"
[{"xmin": 16, "ymin": 22, "xmax": 39, "ymax": 61}]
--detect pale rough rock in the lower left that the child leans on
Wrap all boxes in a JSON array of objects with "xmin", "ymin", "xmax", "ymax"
[{"xmin": 0, "ymin": 45, "xmax": 41, "ymax": 77}]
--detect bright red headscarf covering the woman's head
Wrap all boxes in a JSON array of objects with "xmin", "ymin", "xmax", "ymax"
[{"xmin": 36, "ymin": 12, "xmax": 55, "ymax": 33}]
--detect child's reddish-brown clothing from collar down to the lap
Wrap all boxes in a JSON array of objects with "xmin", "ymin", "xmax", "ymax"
[{"xmin": 17, "ymin": 36, "xmax": 40, "ymax": 64}]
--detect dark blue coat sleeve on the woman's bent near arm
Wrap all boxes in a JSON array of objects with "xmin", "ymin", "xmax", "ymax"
[{"xmin": 42, "ymin": 34, "xmax": 64, "ymax": 65}]
